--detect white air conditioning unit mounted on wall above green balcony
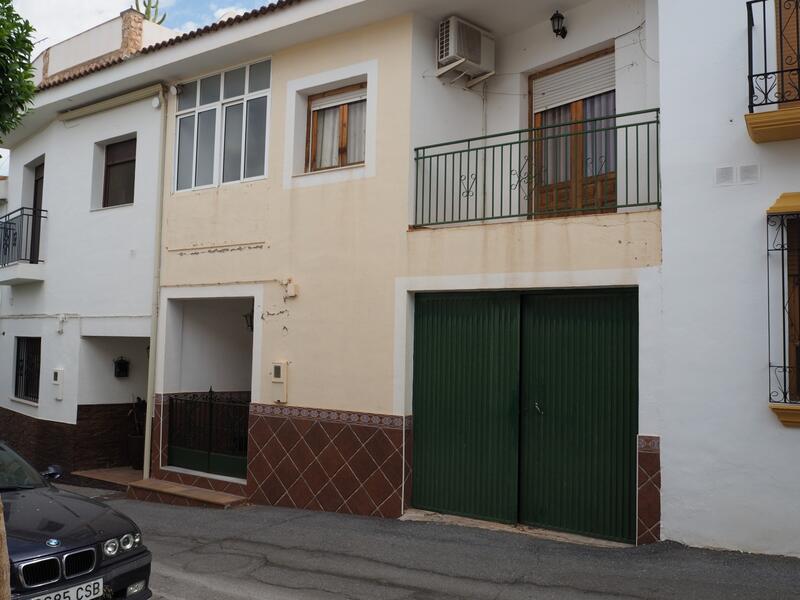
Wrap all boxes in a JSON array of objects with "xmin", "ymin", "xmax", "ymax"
[{"xmin": 437, "ymin": 17, "xmax": 494, "ymax": 77}]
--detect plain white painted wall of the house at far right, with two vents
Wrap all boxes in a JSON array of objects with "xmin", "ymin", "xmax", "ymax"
[{"xmin": 652, "ymin": 0, "xmax": 800, "ymax": 556}]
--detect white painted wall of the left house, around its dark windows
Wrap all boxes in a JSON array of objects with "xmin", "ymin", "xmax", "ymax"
[{"xmin": 0, "ymin": 94, "xmax": 161, "ymax": 423}]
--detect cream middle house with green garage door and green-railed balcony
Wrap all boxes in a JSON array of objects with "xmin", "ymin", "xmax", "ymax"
[{"xmin": 138, "ymin": 0, "xmax": 662, "ymax": 543}]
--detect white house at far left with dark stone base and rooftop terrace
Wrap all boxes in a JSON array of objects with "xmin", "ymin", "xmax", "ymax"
[{"xmin": 0, "ymin": 10, "xmax": 174, "ymax": 471}]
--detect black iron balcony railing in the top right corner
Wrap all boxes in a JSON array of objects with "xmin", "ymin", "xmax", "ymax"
[{"xmin": 747, "ymin": 0, "xmax": 800, "ymax": 112}]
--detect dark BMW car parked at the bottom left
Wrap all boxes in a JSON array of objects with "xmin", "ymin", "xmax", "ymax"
[{"xmin": 0, "ymin": 442, "xmax": 152, "ymax": 600}]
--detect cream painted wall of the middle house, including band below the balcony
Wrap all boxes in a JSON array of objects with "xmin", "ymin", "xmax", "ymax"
[{"xmin": 156, "ymin": 11, "xmax": 661, "ymax": 414}]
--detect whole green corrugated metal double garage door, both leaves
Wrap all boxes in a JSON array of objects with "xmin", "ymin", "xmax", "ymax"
[{"xmin": 412, "ymin": 290, "xmax": 638, "ymax": 541}]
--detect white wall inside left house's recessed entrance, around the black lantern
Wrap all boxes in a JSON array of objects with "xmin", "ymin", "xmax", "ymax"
[{"xmin": 78, "ymin": 337, "xmax": 150, "ymax": 404}]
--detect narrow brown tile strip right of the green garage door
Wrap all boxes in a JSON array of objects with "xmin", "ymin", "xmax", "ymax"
[{"xmin": 636, "ymin": 435, "xmax": 661, "ymax": 545}]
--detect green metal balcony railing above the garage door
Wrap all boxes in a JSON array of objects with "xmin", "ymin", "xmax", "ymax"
[{"xmin": 412, "ymin": 109, "xmax": 661, "ymax": 227}]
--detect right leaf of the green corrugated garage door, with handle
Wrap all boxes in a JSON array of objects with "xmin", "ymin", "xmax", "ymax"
[{"xmin": 519, "ymin": 290, "xmax": 638, "ymax": 542}]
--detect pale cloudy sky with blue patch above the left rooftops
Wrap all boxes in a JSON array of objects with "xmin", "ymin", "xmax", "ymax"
[{"xmin": 13, "ymin": 0, "xmax": 268, "ymax": 50}]
